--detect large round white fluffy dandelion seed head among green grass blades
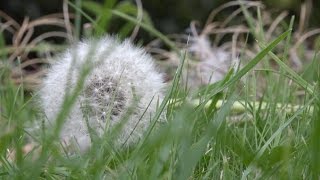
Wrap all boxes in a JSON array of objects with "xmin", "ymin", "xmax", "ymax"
[{"xmin": 40, "ymin": 36, "xmax": 165, "ymax": 150}]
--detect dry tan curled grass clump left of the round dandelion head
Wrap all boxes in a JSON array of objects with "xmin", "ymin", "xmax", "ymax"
[{"xmin": 0, "ymin": 11, "xmax": 72, "ymax": 90}]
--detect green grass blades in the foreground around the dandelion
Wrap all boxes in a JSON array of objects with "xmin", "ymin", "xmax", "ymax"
[{"xmin": 0, "ymin": 0, "xmax": 320, "ymax": 179}]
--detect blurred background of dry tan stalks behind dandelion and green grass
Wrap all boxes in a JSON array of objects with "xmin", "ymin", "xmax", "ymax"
[{"xmin": 0, "ymin": 0, "xmax": 320, "ymax": 89}]
